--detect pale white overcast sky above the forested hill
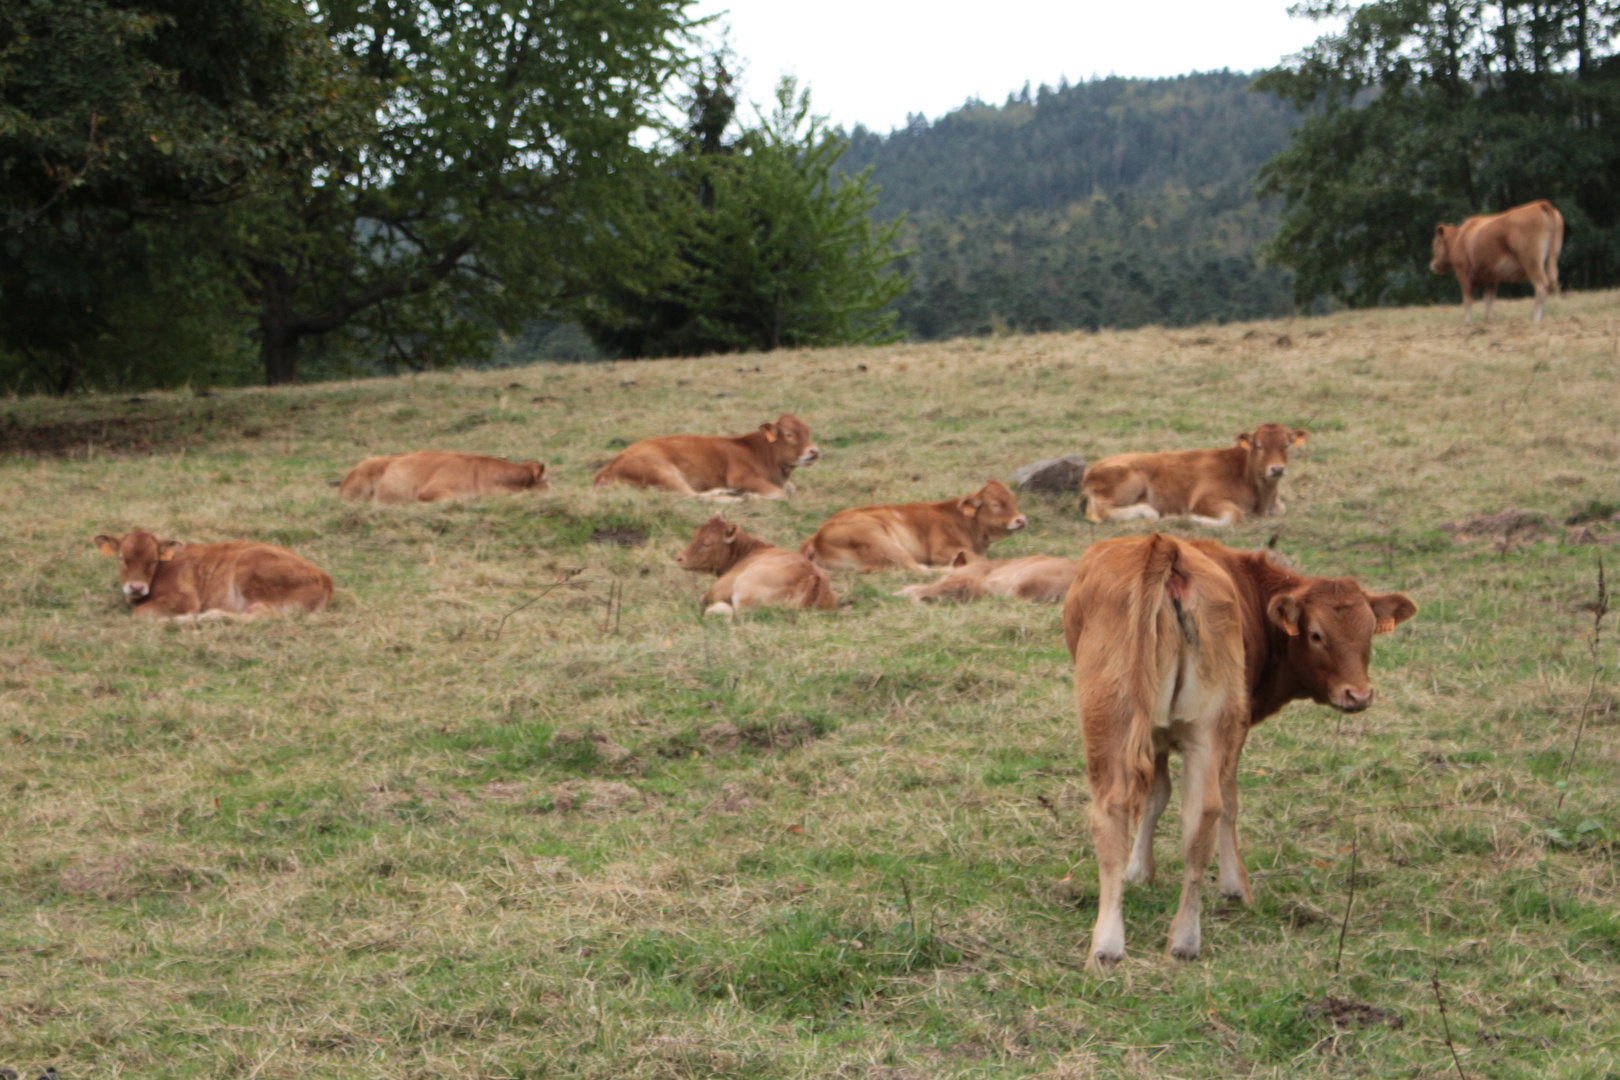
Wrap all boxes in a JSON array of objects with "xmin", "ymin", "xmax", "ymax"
[{"xmin": 695, "ymin": 0, "xmax": 1328, "ymax": 131}]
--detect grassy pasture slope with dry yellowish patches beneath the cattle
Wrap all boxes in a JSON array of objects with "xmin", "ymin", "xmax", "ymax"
[{"xmin": 0, "ymin": 293, "xmax": 1620, "ymax": 1080}]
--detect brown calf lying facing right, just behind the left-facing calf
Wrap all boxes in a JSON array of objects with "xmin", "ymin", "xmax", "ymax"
[{"xmin": 799, "ymin": 479, "xmax": 1029, "ymax": 570}]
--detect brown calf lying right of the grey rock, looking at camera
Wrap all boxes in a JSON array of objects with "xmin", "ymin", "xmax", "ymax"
[{"xmin": 1081, "ymin": 424, "xmax": 1311, "ymax": 525}]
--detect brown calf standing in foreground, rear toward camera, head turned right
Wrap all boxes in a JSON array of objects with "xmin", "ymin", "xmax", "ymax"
[{"xmin": 1063, "ymin": 533, "xmax": 1418, "ymax": 968}]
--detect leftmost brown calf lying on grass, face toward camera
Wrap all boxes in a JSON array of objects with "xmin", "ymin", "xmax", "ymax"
[{"xmin": 96, "ymin": 529, "xmax": 332, "ymax": 622}]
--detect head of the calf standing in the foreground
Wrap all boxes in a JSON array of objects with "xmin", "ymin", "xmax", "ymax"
[{"xmin": 1265, "ymin": 578, "xmax": 1418, "ymax": 712}]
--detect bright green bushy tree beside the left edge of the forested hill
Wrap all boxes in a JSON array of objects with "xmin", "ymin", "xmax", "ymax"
[{"xmin": 578, "ymin": 78, "xmax": 907, "ymax": 356}]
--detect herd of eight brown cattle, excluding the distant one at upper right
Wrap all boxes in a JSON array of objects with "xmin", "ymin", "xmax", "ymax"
[{"xmin": 96, "ymin": 383, "xmax": 1418, "ymax": 967}]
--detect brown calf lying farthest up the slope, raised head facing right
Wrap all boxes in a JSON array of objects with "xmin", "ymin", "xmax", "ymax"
[{"xmin": 595, "ymin": 413, "xmax": 821, "ymax": 499}]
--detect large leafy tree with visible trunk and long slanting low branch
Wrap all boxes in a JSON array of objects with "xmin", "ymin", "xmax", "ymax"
[{"xmin": 225, "ymin": 0, "xmax": 692, "ymax": 384}]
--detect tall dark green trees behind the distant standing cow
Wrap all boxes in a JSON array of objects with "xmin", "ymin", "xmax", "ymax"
[{"xmin": 1256, "ymin": 0, "xmax": 1620, "ymax": 306}]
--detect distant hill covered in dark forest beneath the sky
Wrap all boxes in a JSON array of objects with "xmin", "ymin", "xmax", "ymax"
[{"xmin": 841, "ymin": 71, "xmax": 1298, "ymax": 338}]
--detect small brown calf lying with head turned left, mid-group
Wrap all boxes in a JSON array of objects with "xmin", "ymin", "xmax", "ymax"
[{"xmin": 676, "ymin": 513, "xmax": 838, "ymax": 615}]
